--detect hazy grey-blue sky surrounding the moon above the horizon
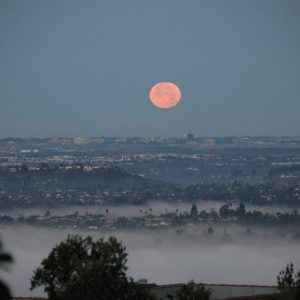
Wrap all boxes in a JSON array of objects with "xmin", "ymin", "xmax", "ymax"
[{"xmin": 0, "ymin": 0, "xmax": 300, "ymax": 137}]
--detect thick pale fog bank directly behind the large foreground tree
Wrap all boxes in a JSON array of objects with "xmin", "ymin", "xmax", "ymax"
[{"xmin": 0, "ymin": 226, "xmax": 300, "ymax": 296}]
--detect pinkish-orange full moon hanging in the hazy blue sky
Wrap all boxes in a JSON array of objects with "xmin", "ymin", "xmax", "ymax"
[{"xmin": 149, "ymin": 82, "xmax": 181, "ymax": 108}]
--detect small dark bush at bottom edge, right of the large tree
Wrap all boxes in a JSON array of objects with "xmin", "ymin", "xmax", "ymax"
[{"xmin": 177, "ymin": 281, "xmax": 211, "ymax": 300}]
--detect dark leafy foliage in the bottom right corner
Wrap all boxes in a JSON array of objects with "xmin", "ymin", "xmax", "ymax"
[{"xmin": 277, "ymin": 262, "xmax": 300, "ymax": 300}]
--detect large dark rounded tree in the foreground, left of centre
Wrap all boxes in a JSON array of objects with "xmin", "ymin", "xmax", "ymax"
[{"xmin": 31, "ymin": 235, "xmax": 157, "ymax": 300}]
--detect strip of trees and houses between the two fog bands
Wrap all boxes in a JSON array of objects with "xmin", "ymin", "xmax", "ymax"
[{"xmin": 0, "ymin": 204, "xmax": 300, "ymax": 231}]
